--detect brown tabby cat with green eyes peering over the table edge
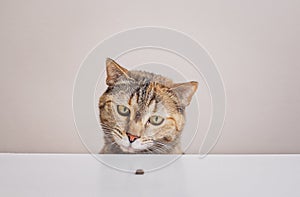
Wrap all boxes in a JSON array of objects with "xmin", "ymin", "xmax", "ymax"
[{"xmin": 99, "ymin": 58, "xmax": 198, "ymax": 154}]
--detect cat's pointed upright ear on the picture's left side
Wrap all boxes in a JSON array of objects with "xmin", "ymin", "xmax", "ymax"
[{"xmin": 106, "ymin": 58, "xmax": 128, "ymax": 86}]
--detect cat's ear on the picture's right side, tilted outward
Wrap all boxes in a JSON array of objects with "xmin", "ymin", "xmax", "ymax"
[{"xmin": 171, "ymin": 81, "xmax": 198, "ymax": 107}]
